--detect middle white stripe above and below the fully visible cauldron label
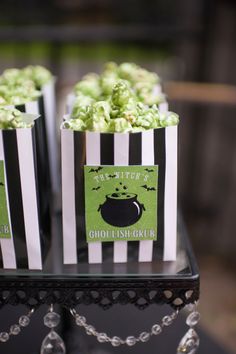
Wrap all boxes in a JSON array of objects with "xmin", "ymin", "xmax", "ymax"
[{"xmin": 113, "ymin": 133, "xmax": 129, "ymax": 263}]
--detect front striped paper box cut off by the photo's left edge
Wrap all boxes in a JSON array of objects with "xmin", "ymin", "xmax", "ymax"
[{"xmin": 0, "ymin": 115, "xmax": 48, "ymax": 270}]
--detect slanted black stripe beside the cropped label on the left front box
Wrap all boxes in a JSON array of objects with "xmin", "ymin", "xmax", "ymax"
[{"xmin": 2, "ymin": 130, "xmax": 28, "ymax": 268}]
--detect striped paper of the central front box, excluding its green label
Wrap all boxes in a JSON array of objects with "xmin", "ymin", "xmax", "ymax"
[{"xmin": 61, "ymin": 103, "xmax": 177, "ymax": 264}]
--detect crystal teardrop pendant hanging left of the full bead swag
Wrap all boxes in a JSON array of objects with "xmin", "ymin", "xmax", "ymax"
[{"xmin": 40, "ymin": 305, "xmax": 66, "ymax": 354}]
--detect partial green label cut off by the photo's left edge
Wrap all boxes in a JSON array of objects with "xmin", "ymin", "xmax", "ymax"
[{"xmin": 0, "ymin": 161, "xmax": 11, "ymax": 238}]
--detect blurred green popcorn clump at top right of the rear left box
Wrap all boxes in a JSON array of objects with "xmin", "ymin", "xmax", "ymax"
[{"xmin": 21, "ymin": 65, "xmax": 52, "ymax": 89}]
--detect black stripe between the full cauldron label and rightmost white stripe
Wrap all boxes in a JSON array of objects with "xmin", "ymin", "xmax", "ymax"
[{"xmin": 154, "ymin": 128, "xmax": 166, "ymax": 255}]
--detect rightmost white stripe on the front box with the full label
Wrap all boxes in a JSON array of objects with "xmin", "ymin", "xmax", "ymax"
[{"xmin": 164, "ymin": 126, "xmax": 178, "ymax": 261}]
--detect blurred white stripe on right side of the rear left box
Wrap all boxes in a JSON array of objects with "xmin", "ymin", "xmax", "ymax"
[{"xmin": 42, "ymin": 80, "xmax": 59, "ymax": 192}]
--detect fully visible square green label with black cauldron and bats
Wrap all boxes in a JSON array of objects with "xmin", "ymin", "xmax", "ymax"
[{"xmin": 84, "ymin": 166, "xmax": 158, "ymax": 242}]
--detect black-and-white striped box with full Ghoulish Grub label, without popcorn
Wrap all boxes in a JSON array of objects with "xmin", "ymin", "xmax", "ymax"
[{"xmin": 61, "ymin": 103, "xmax": 177, "ymax": 264}]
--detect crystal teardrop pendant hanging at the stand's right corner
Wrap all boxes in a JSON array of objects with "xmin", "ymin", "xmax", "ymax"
[{"xmin": 177, "ymin": 303, "xmax": 200, "ymax": 354}]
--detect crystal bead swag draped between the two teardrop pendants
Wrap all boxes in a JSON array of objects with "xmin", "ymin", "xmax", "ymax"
[{"xmin": 69, "ymin": 309, "xmax": 179, "ymax": 348}]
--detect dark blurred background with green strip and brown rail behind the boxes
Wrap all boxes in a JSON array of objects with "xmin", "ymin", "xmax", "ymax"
[{"xmin": 0, "ymin": 0, "xmax": 236, "ymax": 353}]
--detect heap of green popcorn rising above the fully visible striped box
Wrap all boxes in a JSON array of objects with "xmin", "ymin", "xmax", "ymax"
[{"xmin": 65, "ymin": 62, "xmax": 179, "ymax": 133}]
